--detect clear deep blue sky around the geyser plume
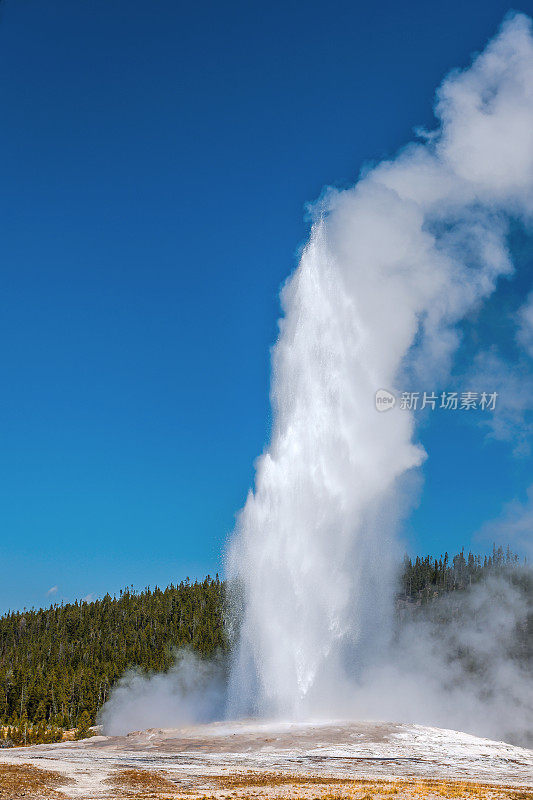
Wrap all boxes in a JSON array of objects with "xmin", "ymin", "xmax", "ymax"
[{"xmin": 0, "ymin": 0, "xmax": 533, "ymax": 611}]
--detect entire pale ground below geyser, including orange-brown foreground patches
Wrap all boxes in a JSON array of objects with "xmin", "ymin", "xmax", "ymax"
[{"xmin": 0, "ymin": 721, "xmax": 533, "ymax": 800}]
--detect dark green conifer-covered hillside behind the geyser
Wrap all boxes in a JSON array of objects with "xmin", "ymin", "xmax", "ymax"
[{"xmin": 0, "ymin": 549, "xmax": 517, "ymax": 728}]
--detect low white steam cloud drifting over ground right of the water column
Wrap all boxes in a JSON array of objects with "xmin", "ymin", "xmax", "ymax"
[{"xmin": 348, "ymin": 567, "xmax": 533, "ymax": 746}]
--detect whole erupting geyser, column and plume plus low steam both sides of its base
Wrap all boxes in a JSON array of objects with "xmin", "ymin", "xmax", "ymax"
[{"xmin": 102, "ymin": 14, "xmax": 533, "ymax": 741}]
